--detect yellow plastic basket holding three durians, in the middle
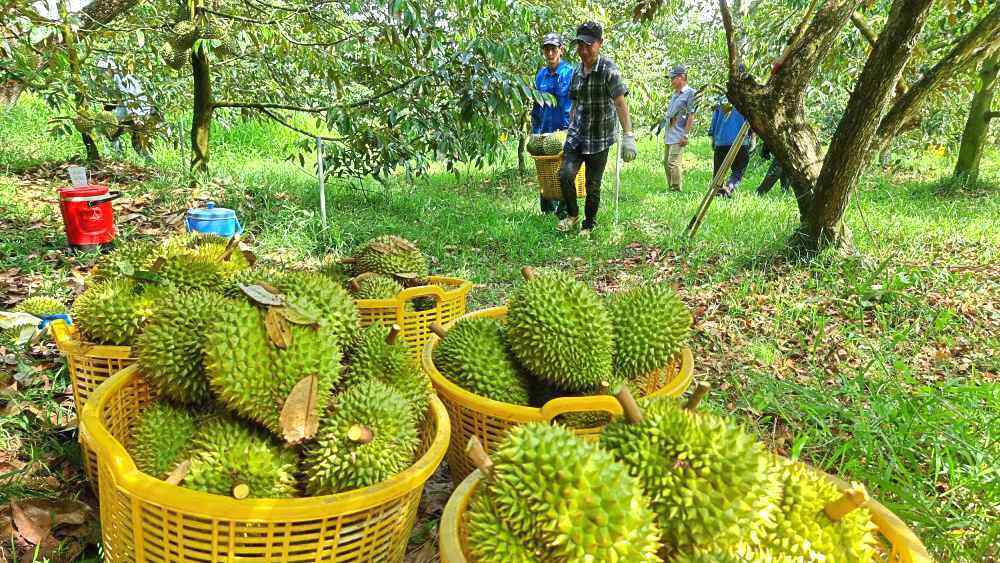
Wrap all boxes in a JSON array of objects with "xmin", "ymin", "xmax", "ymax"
[{"xmin": 421, "ymin": 307, "xmax": 694, "ymax": 484}]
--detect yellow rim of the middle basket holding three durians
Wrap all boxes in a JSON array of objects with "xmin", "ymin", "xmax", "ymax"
[{"xmin": 420, "ymin": 305, "xmax": 694, "ymax": 421}]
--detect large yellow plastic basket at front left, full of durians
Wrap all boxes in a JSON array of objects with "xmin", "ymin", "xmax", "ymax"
[{"xmin": 81, "ymin": 366, "xmax": 450, "ymax": 562}]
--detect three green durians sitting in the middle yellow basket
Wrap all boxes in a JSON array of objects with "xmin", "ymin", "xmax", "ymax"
[{"xmin": 433, "ymin": 268, "xmax": 691, "ymax": 428}]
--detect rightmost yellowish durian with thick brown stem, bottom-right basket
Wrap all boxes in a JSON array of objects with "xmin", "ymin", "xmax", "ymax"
[{"xmin": 765, "ymin": 457, "xmax": 876, "ymax": 563}]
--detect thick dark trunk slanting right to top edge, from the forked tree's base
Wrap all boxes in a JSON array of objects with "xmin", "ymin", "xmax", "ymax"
[{"xmin": 801, "ymin": 0, "xmax": 934, "ymax": 251}]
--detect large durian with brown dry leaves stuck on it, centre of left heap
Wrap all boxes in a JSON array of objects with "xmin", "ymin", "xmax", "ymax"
[{"xmin": 204, "ymin": 298, "xmax": 341, "ymax": 436}]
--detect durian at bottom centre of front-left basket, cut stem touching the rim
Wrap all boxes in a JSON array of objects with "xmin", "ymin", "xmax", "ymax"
[{"xmin": 184, "ymin": 416, "xmax": 298, "ymax": 498}]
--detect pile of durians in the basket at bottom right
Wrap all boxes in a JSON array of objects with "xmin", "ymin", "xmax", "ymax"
[{"xmin": 450, "ymin": 387, "xmax": 896, "ymax": 563}]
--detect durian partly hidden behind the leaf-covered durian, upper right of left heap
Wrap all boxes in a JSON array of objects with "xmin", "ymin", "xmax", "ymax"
[{"xmin": 271, "ymin": 272, "xmax": 358, "ymax": 348}]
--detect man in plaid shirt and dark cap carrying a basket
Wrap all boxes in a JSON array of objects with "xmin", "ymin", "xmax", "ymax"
[{"xmin": 557, "ymin": 21, "xmax": 637, "ymax": 236}]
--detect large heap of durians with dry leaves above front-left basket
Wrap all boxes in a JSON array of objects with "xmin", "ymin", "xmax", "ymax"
[{"xmin": 74, "ymin": 232, "xmax": 431, "ymax": 498}]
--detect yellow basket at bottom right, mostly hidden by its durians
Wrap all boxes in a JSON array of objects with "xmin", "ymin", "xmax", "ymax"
[{"xmin": 438, "ymin": 469, "xmax": 934, "ymax": 563}]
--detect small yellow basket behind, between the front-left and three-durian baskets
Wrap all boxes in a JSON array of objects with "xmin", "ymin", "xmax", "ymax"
[{"xmin": 354, "ymin": 276, "xmax": 472, "ymax": 362}]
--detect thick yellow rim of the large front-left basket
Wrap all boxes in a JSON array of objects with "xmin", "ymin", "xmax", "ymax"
[{"xmin": 80, "ymin": 364, "xmax": 451, "ymax": 522}]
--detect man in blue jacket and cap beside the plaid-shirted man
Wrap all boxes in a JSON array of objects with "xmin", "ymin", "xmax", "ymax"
[{"xmin": 531, "ymin": 33, "xmax": 573, "ymax": 215}]
